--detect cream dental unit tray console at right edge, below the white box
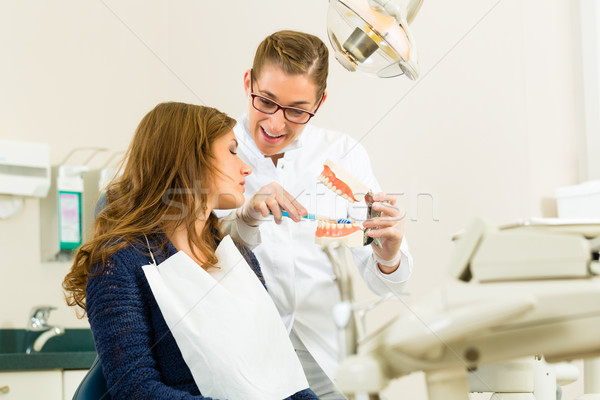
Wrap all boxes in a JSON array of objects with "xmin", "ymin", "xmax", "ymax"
[{"xmin": 450, "ymin": 218, "xmax": 600, "ymax": 282}]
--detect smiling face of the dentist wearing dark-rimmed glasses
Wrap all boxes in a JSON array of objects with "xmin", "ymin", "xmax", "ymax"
[{"xmin": 244, "ymin": 65, "xmax": 320, "ymax": 156}]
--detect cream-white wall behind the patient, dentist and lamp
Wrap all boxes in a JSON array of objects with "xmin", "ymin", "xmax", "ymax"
[{"xmin": 0, "ymin": 0, "xmax": 592, "ymax": 400}]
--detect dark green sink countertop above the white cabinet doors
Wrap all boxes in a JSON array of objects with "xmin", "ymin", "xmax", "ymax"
[{"xmin": 0, "ymin": 328, "xmax": 96, "ymax": 371}]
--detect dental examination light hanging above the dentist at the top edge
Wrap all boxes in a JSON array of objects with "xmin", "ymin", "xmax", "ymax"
[{"xmin": 327, "ymin": 0, "xmax": 423, "ymax": 80}]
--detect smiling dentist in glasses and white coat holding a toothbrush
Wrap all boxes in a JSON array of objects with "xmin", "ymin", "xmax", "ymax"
[{"xmin": 223, "ymin": 31, "xmax": 412, "ymax": 400}]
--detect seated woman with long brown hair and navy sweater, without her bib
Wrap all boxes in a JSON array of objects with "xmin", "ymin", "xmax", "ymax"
[{"xmin": 63, "ymin": 103, "xmax": 316, "ymax": 400}]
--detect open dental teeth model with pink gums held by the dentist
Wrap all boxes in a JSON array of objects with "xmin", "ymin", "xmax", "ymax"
[{"xmin": 315, "ymin": 159, "xmax": 370, "ymax": 247}]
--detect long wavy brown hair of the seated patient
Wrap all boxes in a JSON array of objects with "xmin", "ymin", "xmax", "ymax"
[{"xmin": 63, "ymin": 103, "xmax": 235, "ymax": 317}]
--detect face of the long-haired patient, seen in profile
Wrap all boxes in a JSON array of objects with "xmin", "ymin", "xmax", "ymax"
[{"xmin": 209, "ymin": 130, "xmax": 252, "ymax": 209}]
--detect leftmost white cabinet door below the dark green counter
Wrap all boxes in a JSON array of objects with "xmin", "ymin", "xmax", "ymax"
[{"xmin": 0, "ymin": 370, "xmax": 63, "ymax": 400}]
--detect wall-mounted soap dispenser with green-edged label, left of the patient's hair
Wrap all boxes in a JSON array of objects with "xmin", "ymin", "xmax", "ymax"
[{"xmin": 40, "ymin": 147, "xmax": 107, "ymax": 262}]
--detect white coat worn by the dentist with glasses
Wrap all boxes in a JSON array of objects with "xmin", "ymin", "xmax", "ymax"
[{"xmin": 220, "ymin": 116, "xmax": 412, "ymax": 381}]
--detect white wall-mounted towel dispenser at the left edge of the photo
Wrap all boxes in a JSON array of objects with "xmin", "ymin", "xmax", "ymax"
[{"xmin": 0, "ymin": 140, "xmax": 50, "ymax": 219}]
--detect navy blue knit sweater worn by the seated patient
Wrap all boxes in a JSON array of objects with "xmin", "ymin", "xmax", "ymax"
[{"xmin": 87, "ymin": 233, "xmax": 317, "ymax": 400}]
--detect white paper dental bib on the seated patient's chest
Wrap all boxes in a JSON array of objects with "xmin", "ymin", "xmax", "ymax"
[{"xmin": 143, "ymin": 236, "xmax": 308, "ymax": 400}]
